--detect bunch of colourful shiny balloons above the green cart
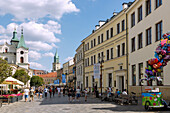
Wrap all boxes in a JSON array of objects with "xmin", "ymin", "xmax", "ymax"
[{"xmin": 142, "ymin": 33, "xmax": 170, "ymax": 81}]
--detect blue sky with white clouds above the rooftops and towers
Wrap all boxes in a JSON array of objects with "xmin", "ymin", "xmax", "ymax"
[{"xmin": 0, "ymin": 0, "xmax": 133, "ymax": 71}]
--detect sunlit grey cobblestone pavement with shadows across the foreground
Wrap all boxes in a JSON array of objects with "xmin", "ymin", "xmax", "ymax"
[{"xmin": 0, "ymin": 95, "xmax": 169, "ymax": 113}]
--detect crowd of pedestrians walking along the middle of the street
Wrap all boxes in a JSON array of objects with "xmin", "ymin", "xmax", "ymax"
[{"xmin": 24, "ymin": 86, "xmax": 88, "ymax": 102}]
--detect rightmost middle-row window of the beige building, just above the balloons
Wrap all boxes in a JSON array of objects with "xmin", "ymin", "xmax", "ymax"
[{"xmin": 156, "ymin": 21, "xmax": 162, "ymax": 41}]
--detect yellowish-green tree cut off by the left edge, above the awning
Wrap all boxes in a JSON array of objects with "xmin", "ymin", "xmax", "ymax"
[{"xmin": 0, "ymin": 58, "xmax": 12, "ymax": 83}]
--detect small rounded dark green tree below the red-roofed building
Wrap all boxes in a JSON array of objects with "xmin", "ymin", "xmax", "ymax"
[{"xmin": 30, "ymin": 76, "xmax": 44, "ymax": 86}]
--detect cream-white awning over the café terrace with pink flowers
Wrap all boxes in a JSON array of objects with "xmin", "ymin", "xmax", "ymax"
[{"xmin": 3, "ymin": 77, "xmax": 24, "ymax": 85}]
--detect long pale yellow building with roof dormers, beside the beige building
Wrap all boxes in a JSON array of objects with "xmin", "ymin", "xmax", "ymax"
[{"xmin": 82, "ymin": 7, "xmax": 128, "ymax": 92}]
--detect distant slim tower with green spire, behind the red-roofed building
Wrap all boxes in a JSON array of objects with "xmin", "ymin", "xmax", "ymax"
[{"xmin": 53, "ymin": 50, "xmax": 60, "ymax": 72}]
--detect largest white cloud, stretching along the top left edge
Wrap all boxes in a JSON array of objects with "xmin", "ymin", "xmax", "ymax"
[{"xmin": 0, "ymin": 0, "xmax": 80, "ymax": 21}]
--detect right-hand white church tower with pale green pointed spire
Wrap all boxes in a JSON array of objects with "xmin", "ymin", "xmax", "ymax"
[{"xmin": 16, "ymin": 28, "xmax": 29, "ymax": 69}]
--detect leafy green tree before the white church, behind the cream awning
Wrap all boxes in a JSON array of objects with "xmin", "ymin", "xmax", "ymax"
[{"xmin": 12, "ymin": 69, "xmax": 30, "ymax": 84}]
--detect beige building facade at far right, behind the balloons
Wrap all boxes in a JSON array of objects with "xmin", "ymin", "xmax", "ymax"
[{"xmin": 126, "ymin": 0, "xmax": 170, "ymax": 98}]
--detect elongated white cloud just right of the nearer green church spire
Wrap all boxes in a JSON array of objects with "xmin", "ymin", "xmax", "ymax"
[{"xmin": 26, "ymin": 41, "xmax": 53, "ymax": 51}]
